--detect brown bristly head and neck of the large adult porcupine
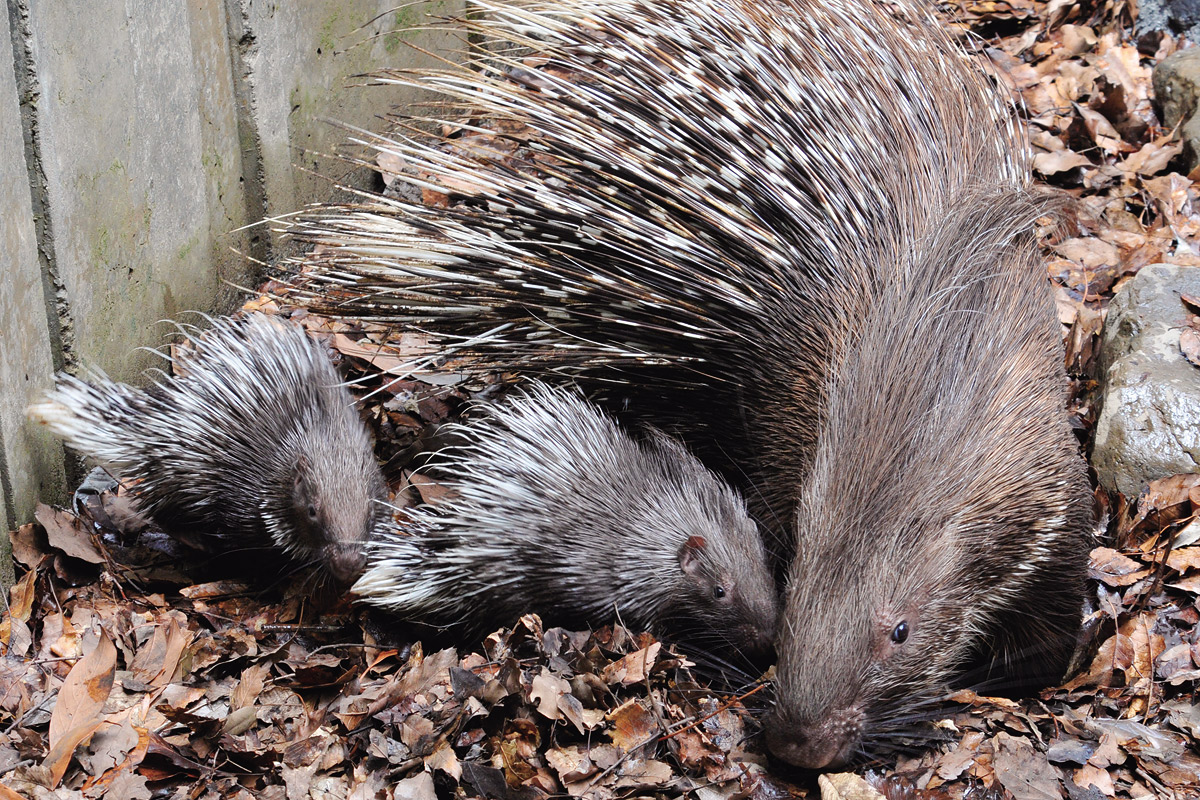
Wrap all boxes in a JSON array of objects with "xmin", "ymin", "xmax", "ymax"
[{"xmin": 766, "ymin": 237, "xmax": 1092, "ymax": 769}]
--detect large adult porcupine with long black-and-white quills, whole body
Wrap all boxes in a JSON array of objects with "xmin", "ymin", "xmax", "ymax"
[{"xmin": 278, "ymin": 0, "xmax": 1091, "ymax": 768}]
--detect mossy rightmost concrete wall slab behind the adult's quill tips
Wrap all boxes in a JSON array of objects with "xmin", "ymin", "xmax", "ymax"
[{"xmin": 229, "ymin": 0, "xmax": 464, "ymax": 242}]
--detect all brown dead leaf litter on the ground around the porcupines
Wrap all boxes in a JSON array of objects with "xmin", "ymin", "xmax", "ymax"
[{"xmin": 0, "ymin": 0, "xmax": 1200, "ymax": 800}]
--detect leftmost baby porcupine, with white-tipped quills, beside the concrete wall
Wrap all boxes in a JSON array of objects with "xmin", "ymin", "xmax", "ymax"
[{"xmin": 29, "ymin": 314, "xmax": 388, "ymax": 582}]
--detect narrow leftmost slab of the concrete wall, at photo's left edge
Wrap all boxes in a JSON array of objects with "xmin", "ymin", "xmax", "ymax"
[{"xmin": 0, "ymin": 6, "xmax": 66, "ymax": 587}]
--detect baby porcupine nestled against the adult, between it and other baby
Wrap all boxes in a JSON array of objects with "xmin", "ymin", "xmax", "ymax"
[{"xmin": 354, "ymin": 385, "xmax": 779, "ymax": 656}]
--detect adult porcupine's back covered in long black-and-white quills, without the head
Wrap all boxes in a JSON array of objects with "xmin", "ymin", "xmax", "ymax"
[{"xmin": 276, "ymin": 0, "xmax": 1025, "ymax": 528}]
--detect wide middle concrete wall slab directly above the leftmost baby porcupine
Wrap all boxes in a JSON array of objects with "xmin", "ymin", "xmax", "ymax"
[{"xmin": 24, "ymin": 0, "xmax": 255, "ymax": 379}]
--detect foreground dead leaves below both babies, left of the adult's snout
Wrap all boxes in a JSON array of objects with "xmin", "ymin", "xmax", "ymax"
[{"xmin": 0, "ymin": 507, "xmax": 764, "ymax": 800}]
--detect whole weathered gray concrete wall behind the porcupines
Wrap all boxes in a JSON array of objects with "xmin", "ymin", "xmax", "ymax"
[{"xmin": 0, "ymin": 0, "xmax": 463, "ymax": 563}]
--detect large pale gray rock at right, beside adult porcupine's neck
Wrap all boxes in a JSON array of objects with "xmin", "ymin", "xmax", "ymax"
[{"xmin": 1092, "ymin": 264, "xmax": 1200, "ymax": 497}]
